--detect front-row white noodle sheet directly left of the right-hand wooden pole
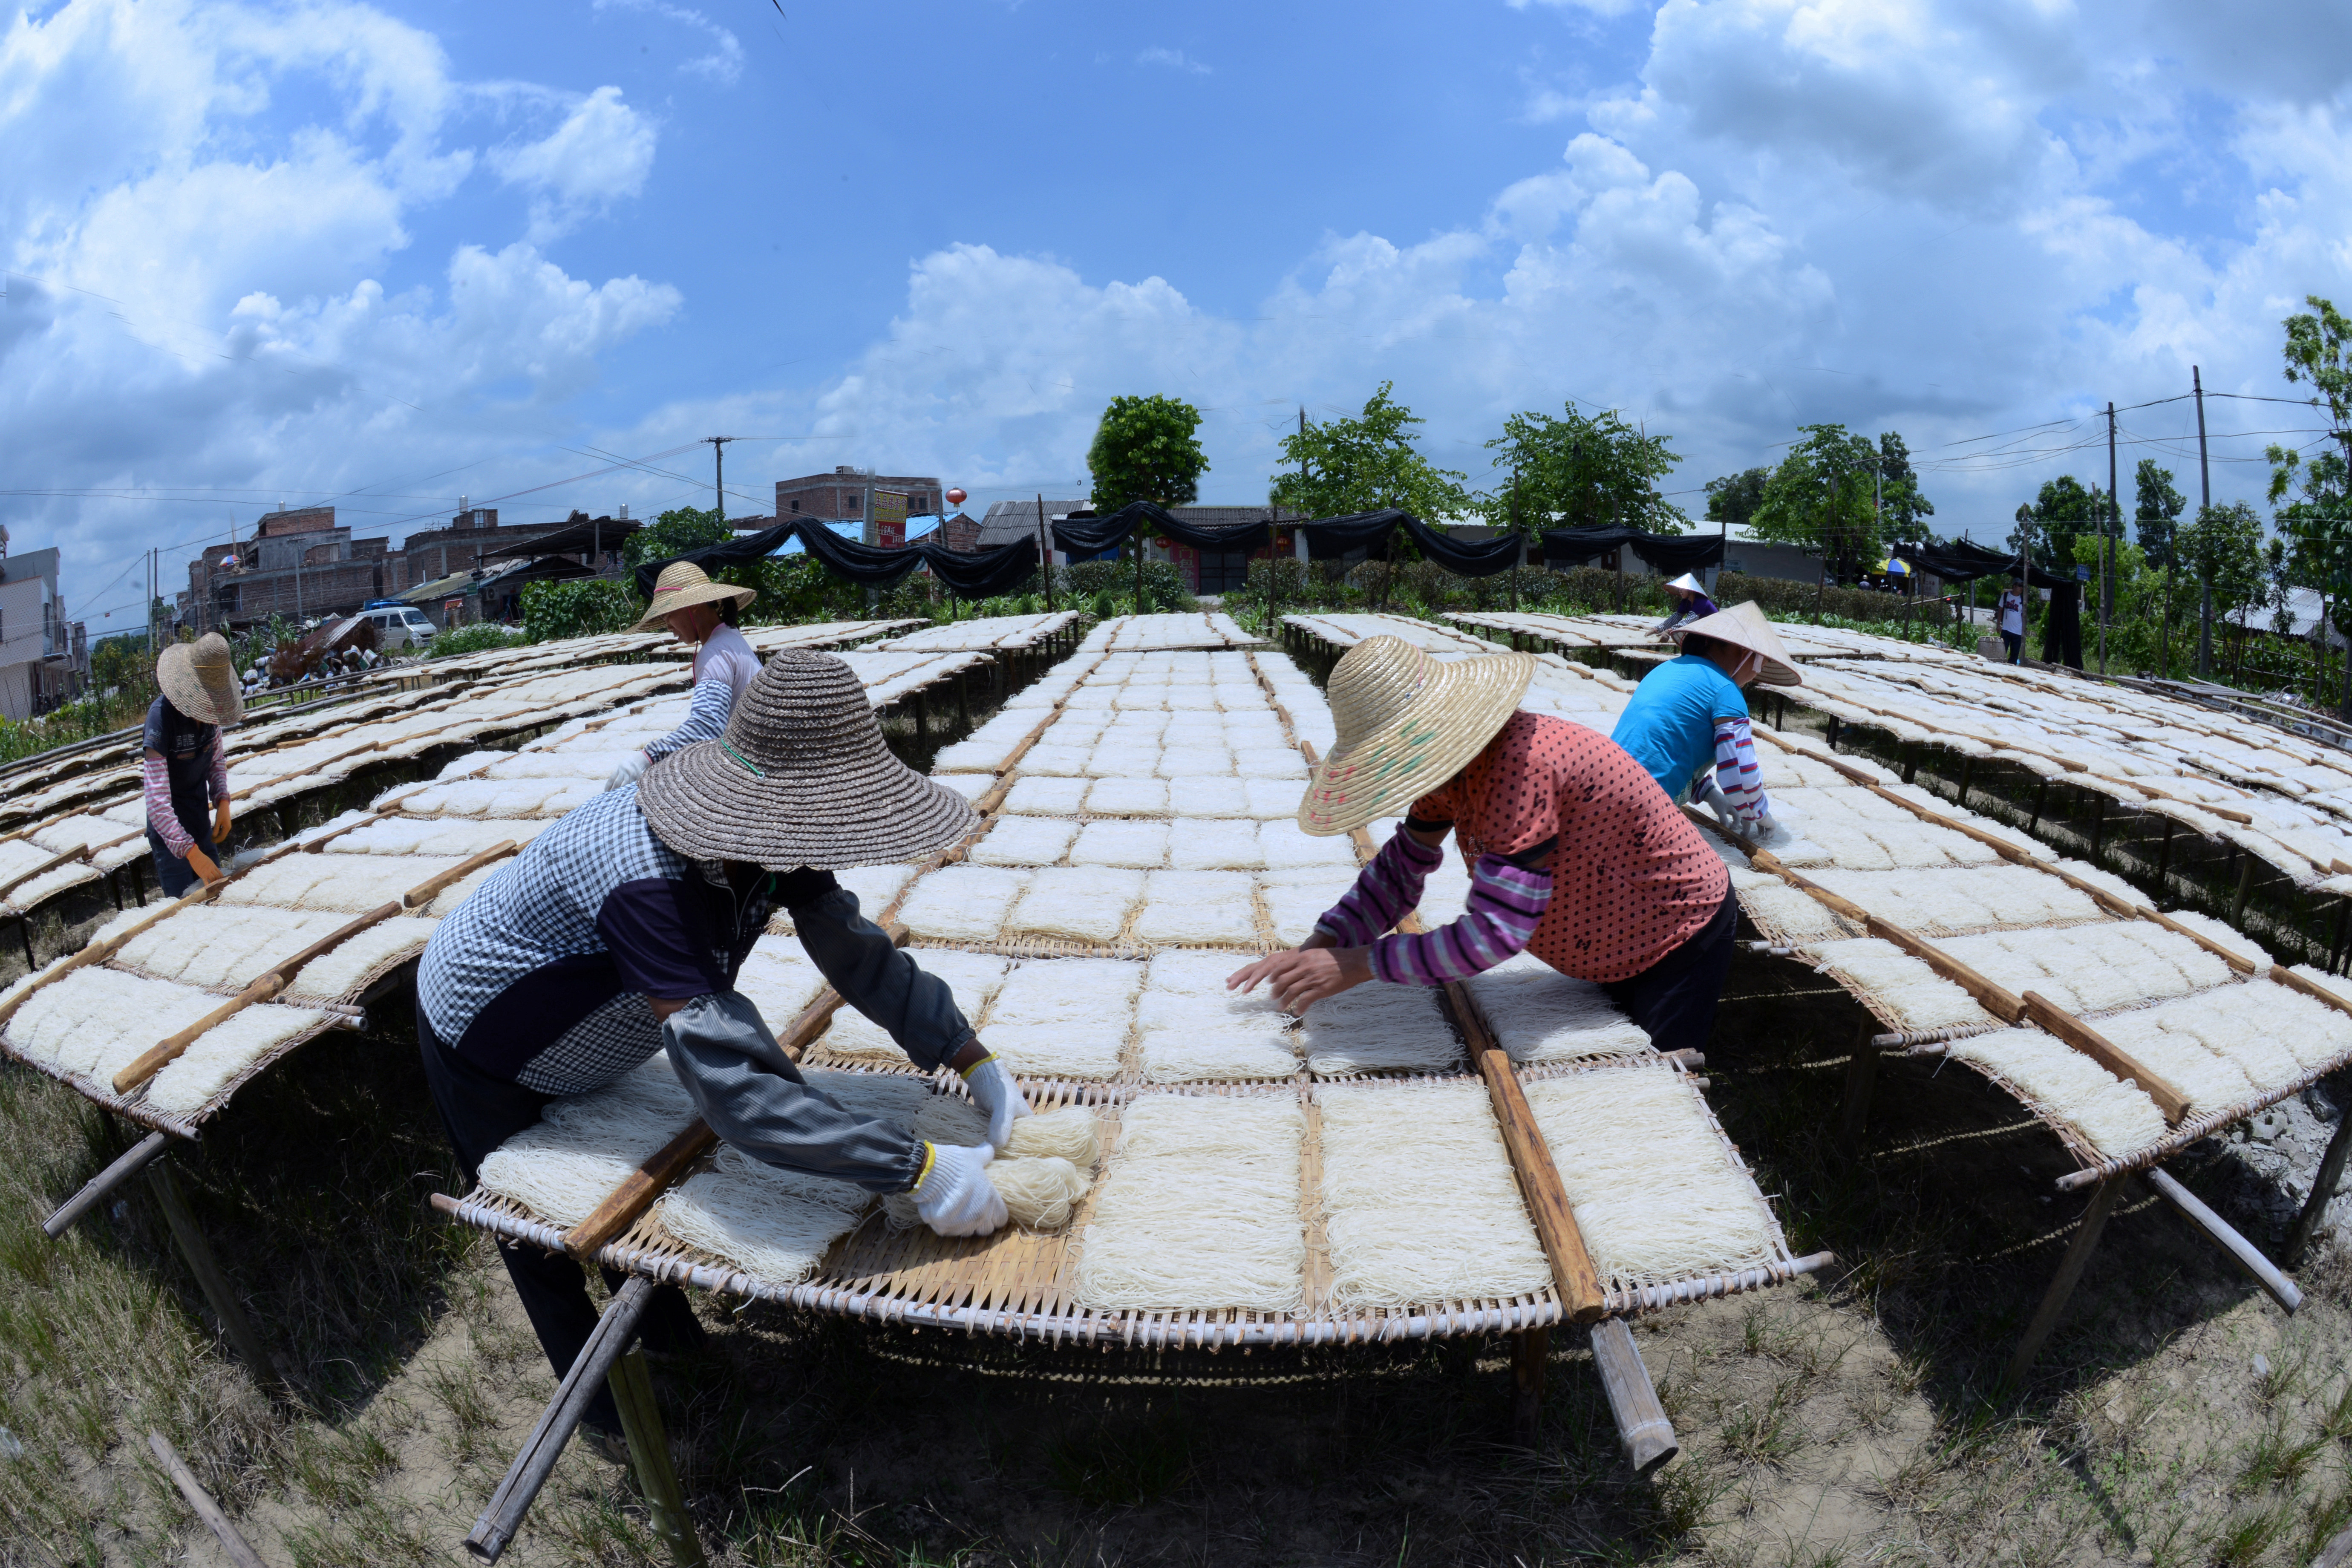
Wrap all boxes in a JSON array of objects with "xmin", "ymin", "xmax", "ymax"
[{"xmin": 1315, "ymin": 1086, "xmax": 1552, "ymax": 1307}]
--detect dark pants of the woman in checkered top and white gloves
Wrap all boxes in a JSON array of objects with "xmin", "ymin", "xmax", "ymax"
[{"xmin": 416, "ymin": 1006, "xmax": 703, "ymax": 1432}]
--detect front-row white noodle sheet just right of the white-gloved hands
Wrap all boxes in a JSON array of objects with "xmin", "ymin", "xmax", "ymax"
[{"xmin": 1075, "ymin": 1093, "xmax": 1308, "ymax": 1312}]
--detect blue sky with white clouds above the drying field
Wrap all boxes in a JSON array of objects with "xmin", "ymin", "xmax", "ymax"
[{"xmin": 0, "ymin": 0, "xmax": 2352, "ymax": 630}]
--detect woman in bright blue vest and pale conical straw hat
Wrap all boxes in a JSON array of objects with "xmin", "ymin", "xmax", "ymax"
[{"xmin": 1609, "ymin": 600, "xmax": 1801, "ymax": 837}]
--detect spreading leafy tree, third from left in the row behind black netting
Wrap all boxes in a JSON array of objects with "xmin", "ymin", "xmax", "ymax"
[{"xmin": 1453, "ymin": 402, "xmax": 1689, "ymax": 533}]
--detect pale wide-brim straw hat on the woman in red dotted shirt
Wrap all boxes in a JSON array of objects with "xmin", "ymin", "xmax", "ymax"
[{"xmin": 1298, "ymin": 637, "xmax": 1536, "ymax": 837}]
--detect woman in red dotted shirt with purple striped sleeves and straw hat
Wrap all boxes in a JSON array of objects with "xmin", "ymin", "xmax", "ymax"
[{"xmin": 1225, "ymin": 637, "xmax": 1738, "ymax": 1051}]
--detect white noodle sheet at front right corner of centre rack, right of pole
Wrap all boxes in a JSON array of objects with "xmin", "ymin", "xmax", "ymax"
[{"xmin": 1526, "ymin": 1067, "xmax": 1778, "ymax": 1283}]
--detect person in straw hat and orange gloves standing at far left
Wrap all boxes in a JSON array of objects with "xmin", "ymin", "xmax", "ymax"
[{"xmin": 141, "ymin": 632, "xmax": 245, "ymax": 898}]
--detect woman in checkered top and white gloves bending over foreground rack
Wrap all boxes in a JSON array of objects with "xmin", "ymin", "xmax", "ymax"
[{"xmin": 416, "ymin": 651, "xmax": 1028, "ymax": 1432}]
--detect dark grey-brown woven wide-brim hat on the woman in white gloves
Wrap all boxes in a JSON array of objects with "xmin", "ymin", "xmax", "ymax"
[{"xmin": 637, "ymin": 649, "xmax": 981, "ymax": 872}]
